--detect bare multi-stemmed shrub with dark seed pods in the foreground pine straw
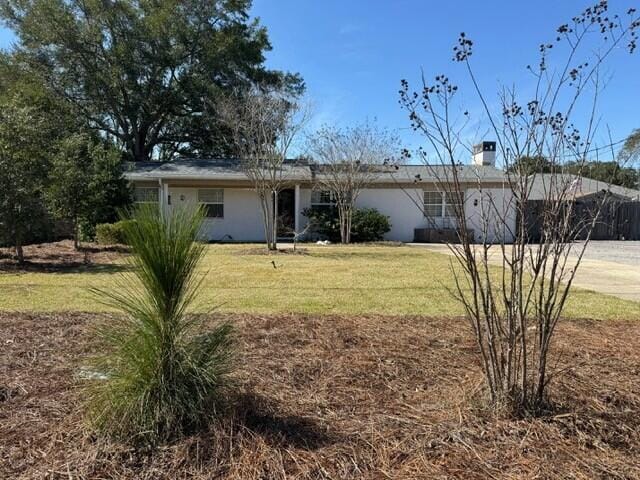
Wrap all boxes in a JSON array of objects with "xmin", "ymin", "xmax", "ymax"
[{"xmin": 400, "ymin": 1, "xmax": 640, "ymax": 412}]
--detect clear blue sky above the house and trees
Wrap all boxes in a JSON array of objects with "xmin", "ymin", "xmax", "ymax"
[{"xmin": 0, "ymin": 0, "xmax": 640, "ymax": 163}]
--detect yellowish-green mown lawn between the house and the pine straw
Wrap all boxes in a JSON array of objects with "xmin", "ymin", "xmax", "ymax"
[{"xmin": 0, "ymin": 245, "xmax": 640, "ymax": 319}]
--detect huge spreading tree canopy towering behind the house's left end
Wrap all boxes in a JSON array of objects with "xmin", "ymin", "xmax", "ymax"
[{"xmin": 0, "ymin": 0, "xmax": 304, "ymax": 161}]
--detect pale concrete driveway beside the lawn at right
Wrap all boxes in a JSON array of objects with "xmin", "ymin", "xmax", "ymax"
[{"xmin": 413, "ymin": 241, "xmax": 640, "ymax": 302}]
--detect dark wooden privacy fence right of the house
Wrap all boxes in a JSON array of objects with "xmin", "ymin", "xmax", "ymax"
[{"xmin": 518, "ymin": 200, "xmax": 640, "ymax": 242}]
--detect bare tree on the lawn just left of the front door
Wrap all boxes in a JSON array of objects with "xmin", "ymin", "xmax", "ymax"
[{"xmin": 221, "ymin": 89, "xmax": 309, "ymax": 250}]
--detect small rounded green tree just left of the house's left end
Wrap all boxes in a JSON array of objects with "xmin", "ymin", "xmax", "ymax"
[{"xmin": 46, "ymin": 134, "xmax": 128, "ymax": 248}]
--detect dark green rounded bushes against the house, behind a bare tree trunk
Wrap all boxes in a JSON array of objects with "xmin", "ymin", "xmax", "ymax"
[{"xmin": 302, "ymin": 208, "xmax": 391, "ymax": 242}]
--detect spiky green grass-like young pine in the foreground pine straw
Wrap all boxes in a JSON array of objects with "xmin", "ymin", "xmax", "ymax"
[{"xmin": 88, "ymin": 207, "xmax": 232, "ymax": 444}]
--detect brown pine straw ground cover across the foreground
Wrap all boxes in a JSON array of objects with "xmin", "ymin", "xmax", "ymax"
[{"xmin": 0, "ymin": 313, "xmax": 640, "ymax": 479}]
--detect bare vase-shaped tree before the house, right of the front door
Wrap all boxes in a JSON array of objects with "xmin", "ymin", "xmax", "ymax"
[{"xmin": 308, "ymin": 123, "xmax": 398, "ymax": 243}]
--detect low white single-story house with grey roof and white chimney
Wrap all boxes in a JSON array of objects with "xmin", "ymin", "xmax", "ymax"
[{"xmin": 125, "ymin": 142, "xmax": 515, "ymax": 242}]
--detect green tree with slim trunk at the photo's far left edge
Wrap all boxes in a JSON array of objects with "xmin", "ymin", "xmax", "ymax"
[{"xmin": 0, "ymin": 99, "xmax": 48, "ymax": 263}]
